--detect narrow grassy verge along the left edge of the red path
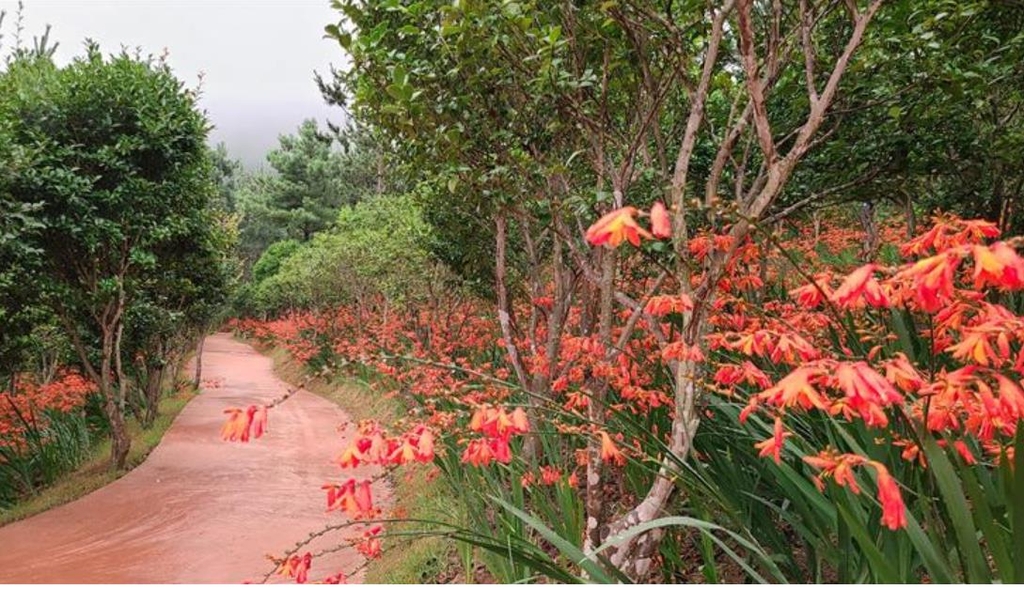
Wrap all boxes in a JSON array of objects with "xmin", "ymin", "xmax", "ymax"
[{"xmin": 0, "ymin": 387, "xmax": 196, "ymax": 525}]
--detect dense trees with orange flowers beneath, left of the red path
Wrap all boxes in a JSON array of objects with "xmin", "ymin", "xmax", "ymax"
[{"xmin": 0, "ymin": 17, "xmax": 233, "ymax": 487}]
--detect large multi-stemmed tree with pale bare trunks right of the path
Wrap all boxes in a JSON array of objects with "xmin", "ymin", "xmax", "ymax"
[{"xmin": 327, "ymin": 0, "xmax": 884, "ymax": 579}]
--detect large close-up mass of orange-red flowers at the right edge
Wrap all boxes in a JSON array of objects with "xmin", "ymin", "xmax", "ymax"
[{"xmin": 729, "ymin": 217, "xmax": 1024, "ymax": 530}]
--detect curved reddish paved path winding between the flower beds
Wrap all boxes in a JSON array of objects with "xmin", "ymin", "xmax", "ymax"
[{"xmin": 0, "ymin": 334, "xmax": 381, "ymax": 583}]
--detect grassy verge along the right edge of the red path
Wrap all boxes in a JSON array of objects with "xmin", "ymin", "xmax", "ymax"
[{"xmin": 264, "ymin": 348, "xmax": 461, "ymax": 584}]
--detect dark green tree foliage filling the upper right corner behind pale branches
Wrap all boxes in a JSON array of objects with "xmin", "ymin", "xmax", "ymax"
[{"xmin": 776, "ymin": 0, "xmax": 1024, "ymax": 235}]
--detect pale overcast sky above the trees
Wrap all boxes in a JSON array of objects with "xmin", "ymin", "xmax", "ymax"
[{"xmin": 0, "ymin": 0, "xmax": 344, "ymax": 168}]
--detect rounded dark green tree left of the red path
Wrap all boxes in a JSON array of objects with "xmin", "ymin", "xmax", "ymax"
[{"xmin": 0, "ymin": 45, "xmax": 224, "ymax": 467}]
